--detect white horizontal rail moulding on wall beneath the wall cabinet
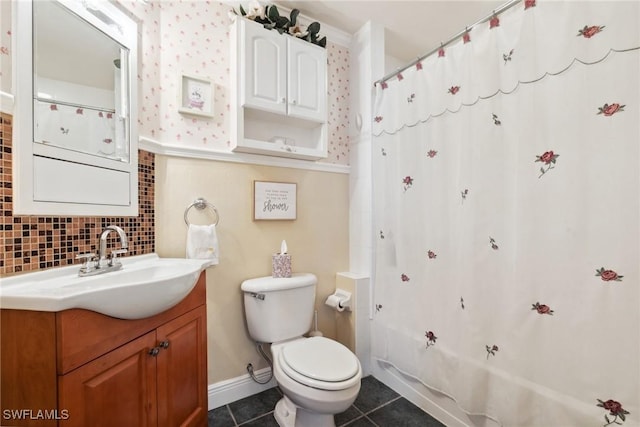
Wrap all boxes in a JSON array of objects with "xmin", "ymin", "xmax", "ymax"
[{"xmin": 138, "ymin": 137, "xmax": 351, "ymax": 174}]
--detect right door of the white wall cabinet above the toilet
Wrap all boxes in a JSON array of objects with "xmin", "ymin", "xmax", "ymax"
[{"xmin": 287, "ymin": 39, "xmax": 327, "ymax": 122}]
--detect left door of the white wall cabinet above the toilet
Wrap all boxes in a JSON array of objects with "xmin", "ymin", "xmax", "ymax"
[{"xmin": 241, "ymin": 22, "xmax": 287, "ymax": 114}]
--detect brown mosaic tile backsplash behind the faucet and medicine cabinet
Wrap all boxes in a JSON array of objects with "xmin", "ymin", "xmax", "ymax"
[{"xmin": 0, "ymin": 114, "xmax": 155, "ymax": 276}]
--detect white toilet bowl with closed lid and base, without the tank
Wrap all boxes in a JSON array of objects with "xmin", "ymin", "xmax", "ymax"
[{"xmin": 271, "ymin": 337, "xmax": 362, "ymax": 427}]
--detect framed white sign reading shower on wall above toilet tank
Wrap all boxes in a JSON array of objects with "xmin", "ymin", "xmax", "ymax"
[{"xmin": 253, "ymin": 181, "xmax": 298, "ymax": 220}]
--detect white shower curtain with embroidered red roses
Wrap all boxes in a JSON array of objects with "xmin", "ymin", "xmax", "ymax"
[{"xmin": 372, "ymin": 0, "xmax": 640, "ymax": 427}]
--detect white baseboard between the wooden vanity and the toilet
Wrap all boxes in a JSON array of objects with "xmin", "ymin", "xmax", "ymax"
[{"xmin": 207, "ymin": 368, "xmax": 277, "ymax": 410}]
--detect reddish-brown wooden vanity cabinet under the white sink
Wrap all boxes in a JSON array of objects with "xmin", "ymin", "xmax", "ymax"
[{"xmin": 0, "ymin": 273, "xmax": 208, "ymax": 427}]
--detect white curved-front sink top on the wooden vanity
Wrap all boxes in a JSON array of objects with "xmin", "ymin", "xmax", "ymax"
[{"xmin": 0, "ymin": 254, "xmax": 215, "ymax": 319}]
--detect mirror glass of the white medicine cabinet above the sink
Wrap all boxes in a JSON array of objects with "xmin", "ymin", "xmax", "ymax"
[{"xmin": 33, "ymin": 1, "xmax": 129, "ymax": 162}]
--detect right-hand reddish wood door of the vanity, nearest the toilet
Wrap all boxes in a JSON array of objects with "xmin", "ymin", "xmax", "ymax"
[{"xmin": 157, "ymin": 306, "xmax": 208, "ymax": 427}]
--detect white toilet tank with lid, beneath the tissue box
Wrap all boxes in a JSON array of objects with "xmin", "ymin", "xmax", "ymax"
[{"xmin": 241, "ymin": 273, "xmax": 318, "ymax": 343}]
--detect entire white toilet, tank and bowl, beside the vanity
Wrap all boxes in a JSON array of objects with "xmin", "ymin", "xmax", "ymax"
[{"xmin": 241, "ymin": 274, "xmax": 362, "ymax": 427}]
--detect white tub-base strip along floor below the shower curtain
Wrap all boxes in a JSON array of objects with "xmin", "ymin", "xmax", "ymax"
[{"xmin": 371, "ymin": 360, "xmax": 476, "ymax": 427}]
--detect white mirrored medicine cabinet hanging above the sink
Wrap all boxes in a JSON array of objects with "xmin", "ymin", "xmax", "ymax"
[{"xmin": 14, "ymin": 0, "xmax": 138, "ymax": 215}]
